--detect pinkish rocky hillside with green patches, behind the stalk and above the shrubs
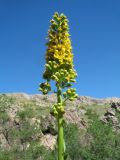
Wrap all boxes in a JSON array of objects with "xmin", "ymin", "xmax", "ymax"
[{"xmin": 0, "ymin": 94, "xmax": 120, "ymax": 158}]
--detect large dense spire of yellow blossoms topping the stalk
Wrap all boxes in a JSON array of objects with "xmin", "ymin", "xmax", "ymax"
[{"xmin": 43, "ymin": 13, "xmax": 76, "ymax": 81}]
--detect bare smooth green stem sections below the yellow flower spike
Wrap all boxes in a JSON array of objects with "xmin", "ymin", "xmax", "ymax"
[{"xmin": 57, "ymin": 85, "xmax": 64, "ymax": 160}]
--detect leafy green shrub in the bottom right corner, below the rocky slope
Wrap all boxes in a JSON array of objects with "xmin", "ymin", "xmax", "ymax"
[{"xmin": 80, "ymin": 113, "xmax": 120, "ymax": 160}]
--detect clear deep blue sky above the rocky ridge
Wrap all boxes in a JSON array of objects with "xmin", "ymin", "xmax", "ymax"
[{"xmin": 0, "ymin": 0, "xmax": 120, "ymax": 98}]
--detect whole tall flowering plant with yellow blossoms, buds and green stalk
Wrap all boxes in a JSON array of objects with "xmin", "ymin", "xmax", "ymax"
[{"xmin": 39, "ymin": 12, "xmax": 77, "ymax": 160}]
